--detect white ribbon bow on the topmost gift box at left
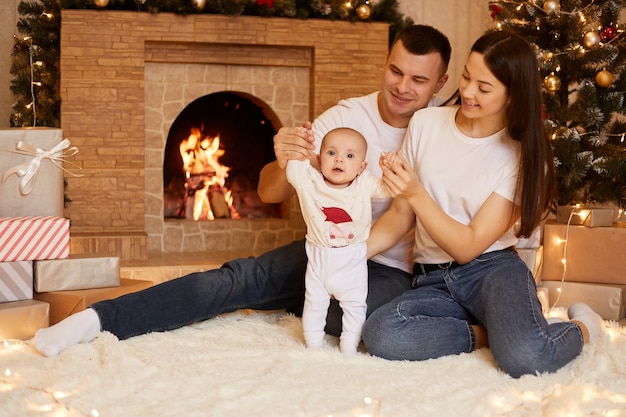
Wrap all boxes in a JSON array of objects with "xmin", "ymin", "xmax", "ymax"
[{"xmin": 0, "ymin": 139, "xmax": 82, "ymax": 195}]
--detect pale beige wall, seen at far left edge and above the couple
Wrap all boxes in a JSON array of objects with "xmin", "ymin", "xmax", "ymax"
[{"xmin": 0, "ymin": 0, "xmax": 491, "ymax": 129}]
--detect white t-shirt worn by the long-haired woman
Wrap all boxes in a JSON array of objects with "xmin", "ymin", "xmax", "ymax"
[{"xmin": 402, "ymin": 106, "xmax": 521, "ymax": 264}]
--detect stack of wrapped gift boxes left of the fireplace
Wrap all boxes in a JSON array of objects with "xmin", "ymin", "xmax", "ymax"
[{"xmin": 0, "ymin": 128, "xmax": 152, "ymax": 340}]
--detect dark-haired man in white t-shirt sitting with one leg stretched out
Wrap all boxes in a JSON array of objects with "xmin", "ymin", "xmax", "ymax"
[{"xmin": 35, "ymin": 25, "xmax": 450, "ymax": 356}]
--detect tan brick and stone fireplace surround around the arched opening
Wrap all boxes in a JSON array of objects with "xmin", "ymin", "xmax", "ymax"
[{"xmin": 60, "ymin": 9, "xmax": 388, "ymax": 260}]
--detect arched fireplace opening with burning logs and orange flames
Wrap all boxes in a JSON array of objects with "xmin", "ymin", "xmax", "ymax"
[{"xmin": 163, "ymin": 91, "xmax": 282, "ymax": 221}]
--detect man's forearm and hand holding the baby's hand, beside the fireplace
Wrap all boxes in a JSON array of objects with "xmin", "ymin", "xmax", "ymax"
[{"xmin": 257, "ymin": 122, "xmax": 315, "ymax": 203}]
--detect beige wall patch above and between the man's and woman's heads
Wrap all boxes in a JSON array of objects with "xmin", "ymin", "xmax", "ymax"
[{"xmin": 398, "ymin": 0, "xmax": 492, "ymax": 97}]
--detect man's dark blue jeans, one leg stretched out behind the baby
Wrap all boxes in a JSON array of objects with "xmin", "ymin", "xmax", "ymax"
[{"xmin": 91, "ymin": 240, "xmax": 411, "ymax": 339}]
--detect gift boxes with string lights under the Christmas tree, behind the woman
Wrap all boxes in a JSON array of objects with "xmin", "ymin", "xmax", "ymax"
[{"xmin": 541, "ymin": 210, "xmax": 626, "ymax": 321}]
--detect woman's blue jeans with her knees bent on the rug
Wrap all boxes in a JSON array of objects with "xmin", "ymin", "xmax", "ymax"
[{"xmin": 363, "ymin": 249, "xmax": 583, "ymax": 378}]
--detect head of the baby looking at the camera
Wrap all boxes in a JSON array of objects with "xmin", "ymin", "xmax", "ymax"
[{"xmin": 320, "ymin": 131, "xmax": 367, "ymax": 186}]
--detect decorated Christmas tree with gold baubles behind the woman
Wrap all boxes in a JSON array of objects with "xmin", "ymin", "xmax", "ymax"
[{"xmin": 490, "ymin": 0, "xmax": 626, "ymax": 207}]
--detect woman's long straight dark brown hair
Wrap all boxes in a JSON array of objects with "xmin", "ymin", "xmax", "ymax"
[{"xmin": 472, "ymin": 31, "xmax": 555, "ymax": 237}]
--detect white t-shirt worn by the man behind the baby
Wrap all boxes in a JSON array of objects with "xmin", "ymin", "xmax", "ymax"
[{"xmin": 313, "ymin": 92, "xmax": 445, "ymax": 272}]
